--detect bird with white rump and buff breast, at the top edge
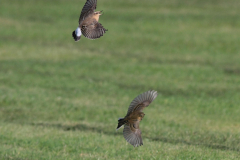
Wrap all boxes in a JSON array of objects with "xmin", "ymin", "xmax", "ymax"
[{"xmin": 72, "ymin": 0, "xmax": 107, "ymax": 42}]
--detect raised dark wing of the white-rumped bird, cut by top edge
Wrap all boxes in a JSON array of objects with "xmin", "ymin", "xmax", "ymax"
[{"xmin": 79, "ymin": 0, "xmax": 97, "ymax": 24}]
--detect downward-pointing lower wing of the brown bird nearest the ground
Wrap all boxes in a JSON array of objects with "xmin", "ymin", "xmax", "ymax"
[{"xmin": 123, "ymin": 121, "xmax": 143, "ymax": 147}]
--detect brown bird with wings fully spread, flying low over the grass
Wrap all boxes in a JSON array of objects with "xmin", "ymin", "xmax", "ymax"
[{"xmin": 117, "ymin": 90, "xmax": 157, "ymax": 147}]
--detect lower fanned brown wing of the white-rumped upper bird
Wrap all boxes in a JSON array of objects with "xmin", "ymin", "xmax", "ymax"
[{"xmin": 81, "ymin": 20, "xmax": 107, "ymax": 39}]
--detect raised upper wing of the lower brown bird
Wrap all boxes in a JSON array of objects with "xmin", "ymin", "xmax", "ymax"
[{"xmin": 126, "ymin": 90, "xmax": 157, "ymax": 116}]
